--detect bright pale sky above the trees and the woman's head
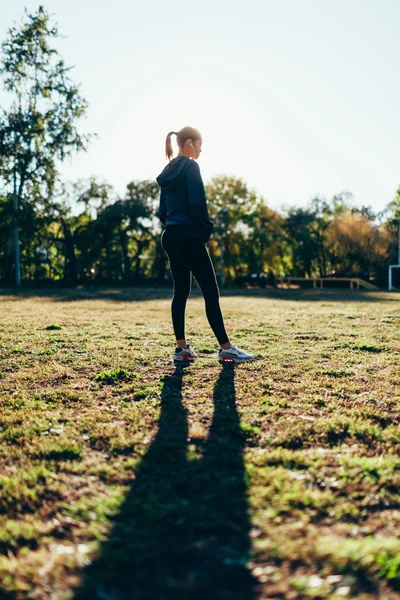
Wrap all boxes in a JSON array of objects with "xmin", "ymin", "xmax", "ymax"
[{"xmin": 0, "ymin": 0, "xmax": 400, "ymax": 216}]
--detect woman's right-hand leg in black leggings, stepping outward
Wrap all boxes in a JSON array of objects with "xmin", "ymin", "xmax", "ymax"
[{"xmin": 190, "ymin": 238, "xmax": 231, "ymax": 348}]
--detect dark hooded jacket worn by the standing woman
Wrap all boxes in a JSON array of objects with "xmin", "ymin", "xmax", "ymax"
[{"xmin": 157, "ymin": 156, "xmax": 214, "ymax": 242}]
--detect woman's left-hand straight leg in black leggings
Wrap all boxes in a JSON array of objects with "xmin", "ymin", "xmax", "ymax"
[{"xmin": 161, "ymin": 229, "xmax": 191, "ymax": 348}]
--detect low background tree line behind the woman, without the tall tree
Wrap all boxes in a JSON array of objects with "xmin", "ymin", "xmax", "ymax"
[{"xmin": 0, "ymin": 176, "xmax": 400, "ymax": 285}]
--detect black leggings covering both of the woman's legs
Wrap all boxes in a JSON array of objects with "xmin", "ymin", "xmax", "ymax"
[{"xmin": 161, "ymin": 227, "xmax": 229, "ymax": 345}]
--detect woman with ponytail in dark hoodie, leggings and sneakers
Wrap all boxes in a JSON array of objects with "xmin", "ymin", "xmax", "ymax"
[{"xmin": 157, "ymin": 127, "xmax": 254, "ymax": 362}]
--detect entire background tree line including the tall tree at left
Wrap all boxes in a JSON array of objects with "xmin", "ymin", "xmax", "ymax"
[{"xmin": 0, "ymin": 6, "xmax": 400, "ymax": 285}]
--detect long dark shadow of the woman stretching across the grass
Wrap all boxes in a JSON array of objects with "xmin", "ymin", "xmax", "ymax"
[{"xmin": 75, "ymin": 365, "xmax": 254, "ymax": 600}]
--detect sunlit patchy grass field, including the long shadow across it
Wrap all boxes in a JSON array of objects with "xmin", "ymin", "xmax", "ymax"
[{"xmin": 0, "ymin": 290, "xmax": 400, "ymax": 600}]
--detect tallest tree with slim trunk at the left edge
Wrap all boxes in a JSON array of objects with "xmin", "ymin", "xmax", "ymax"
[{"xmin": 0, "ymin": 6, "xmax": 90, "ymax": 285}]
